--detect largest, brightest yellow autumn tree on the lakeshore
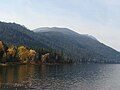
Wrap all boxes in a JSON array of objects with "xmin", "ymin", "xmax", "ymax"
[{"xmin": 18, "ymin": 46, "xmax": 29, "ymax": 62}]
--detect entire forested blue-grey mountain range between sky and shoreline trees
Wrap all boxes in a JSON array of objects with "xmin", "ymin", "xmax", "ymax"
[{"xmin": 0, "ymin": 22, "xmax": 120, "ymax": 62}]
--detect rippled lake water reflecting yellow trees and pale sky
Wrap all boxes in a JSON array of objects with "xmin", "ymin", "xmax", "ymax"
[{"xmin": 0, "ymin": 64, "xmax": 120, "ymax": 90}]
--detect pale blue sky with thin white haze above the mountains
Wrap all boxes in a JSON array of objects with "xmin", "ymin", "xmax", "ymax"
[{"xmin": 0, "ymin": 0, "xmax": 120, "ymax": 51}]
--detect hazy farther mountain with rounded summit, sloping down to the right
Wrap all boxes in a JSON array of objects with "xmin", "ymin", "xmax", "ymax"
[{"xmin": 35, "ymin": 27, "xmax": 120, "ymax": 61}]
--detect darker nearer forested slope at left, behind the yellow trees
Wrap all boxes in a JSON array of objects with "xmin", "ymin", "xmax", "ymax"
[{"xmin": 0, "ymin": 22, "xmax": 45, "ymax": 47}]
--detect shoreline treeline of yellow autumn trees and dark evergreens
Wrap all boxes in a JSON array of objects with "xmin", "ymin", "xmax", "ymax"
[{"xmin": 0, "ymin": 41, "xmax": 72, "ymax": 64}]
